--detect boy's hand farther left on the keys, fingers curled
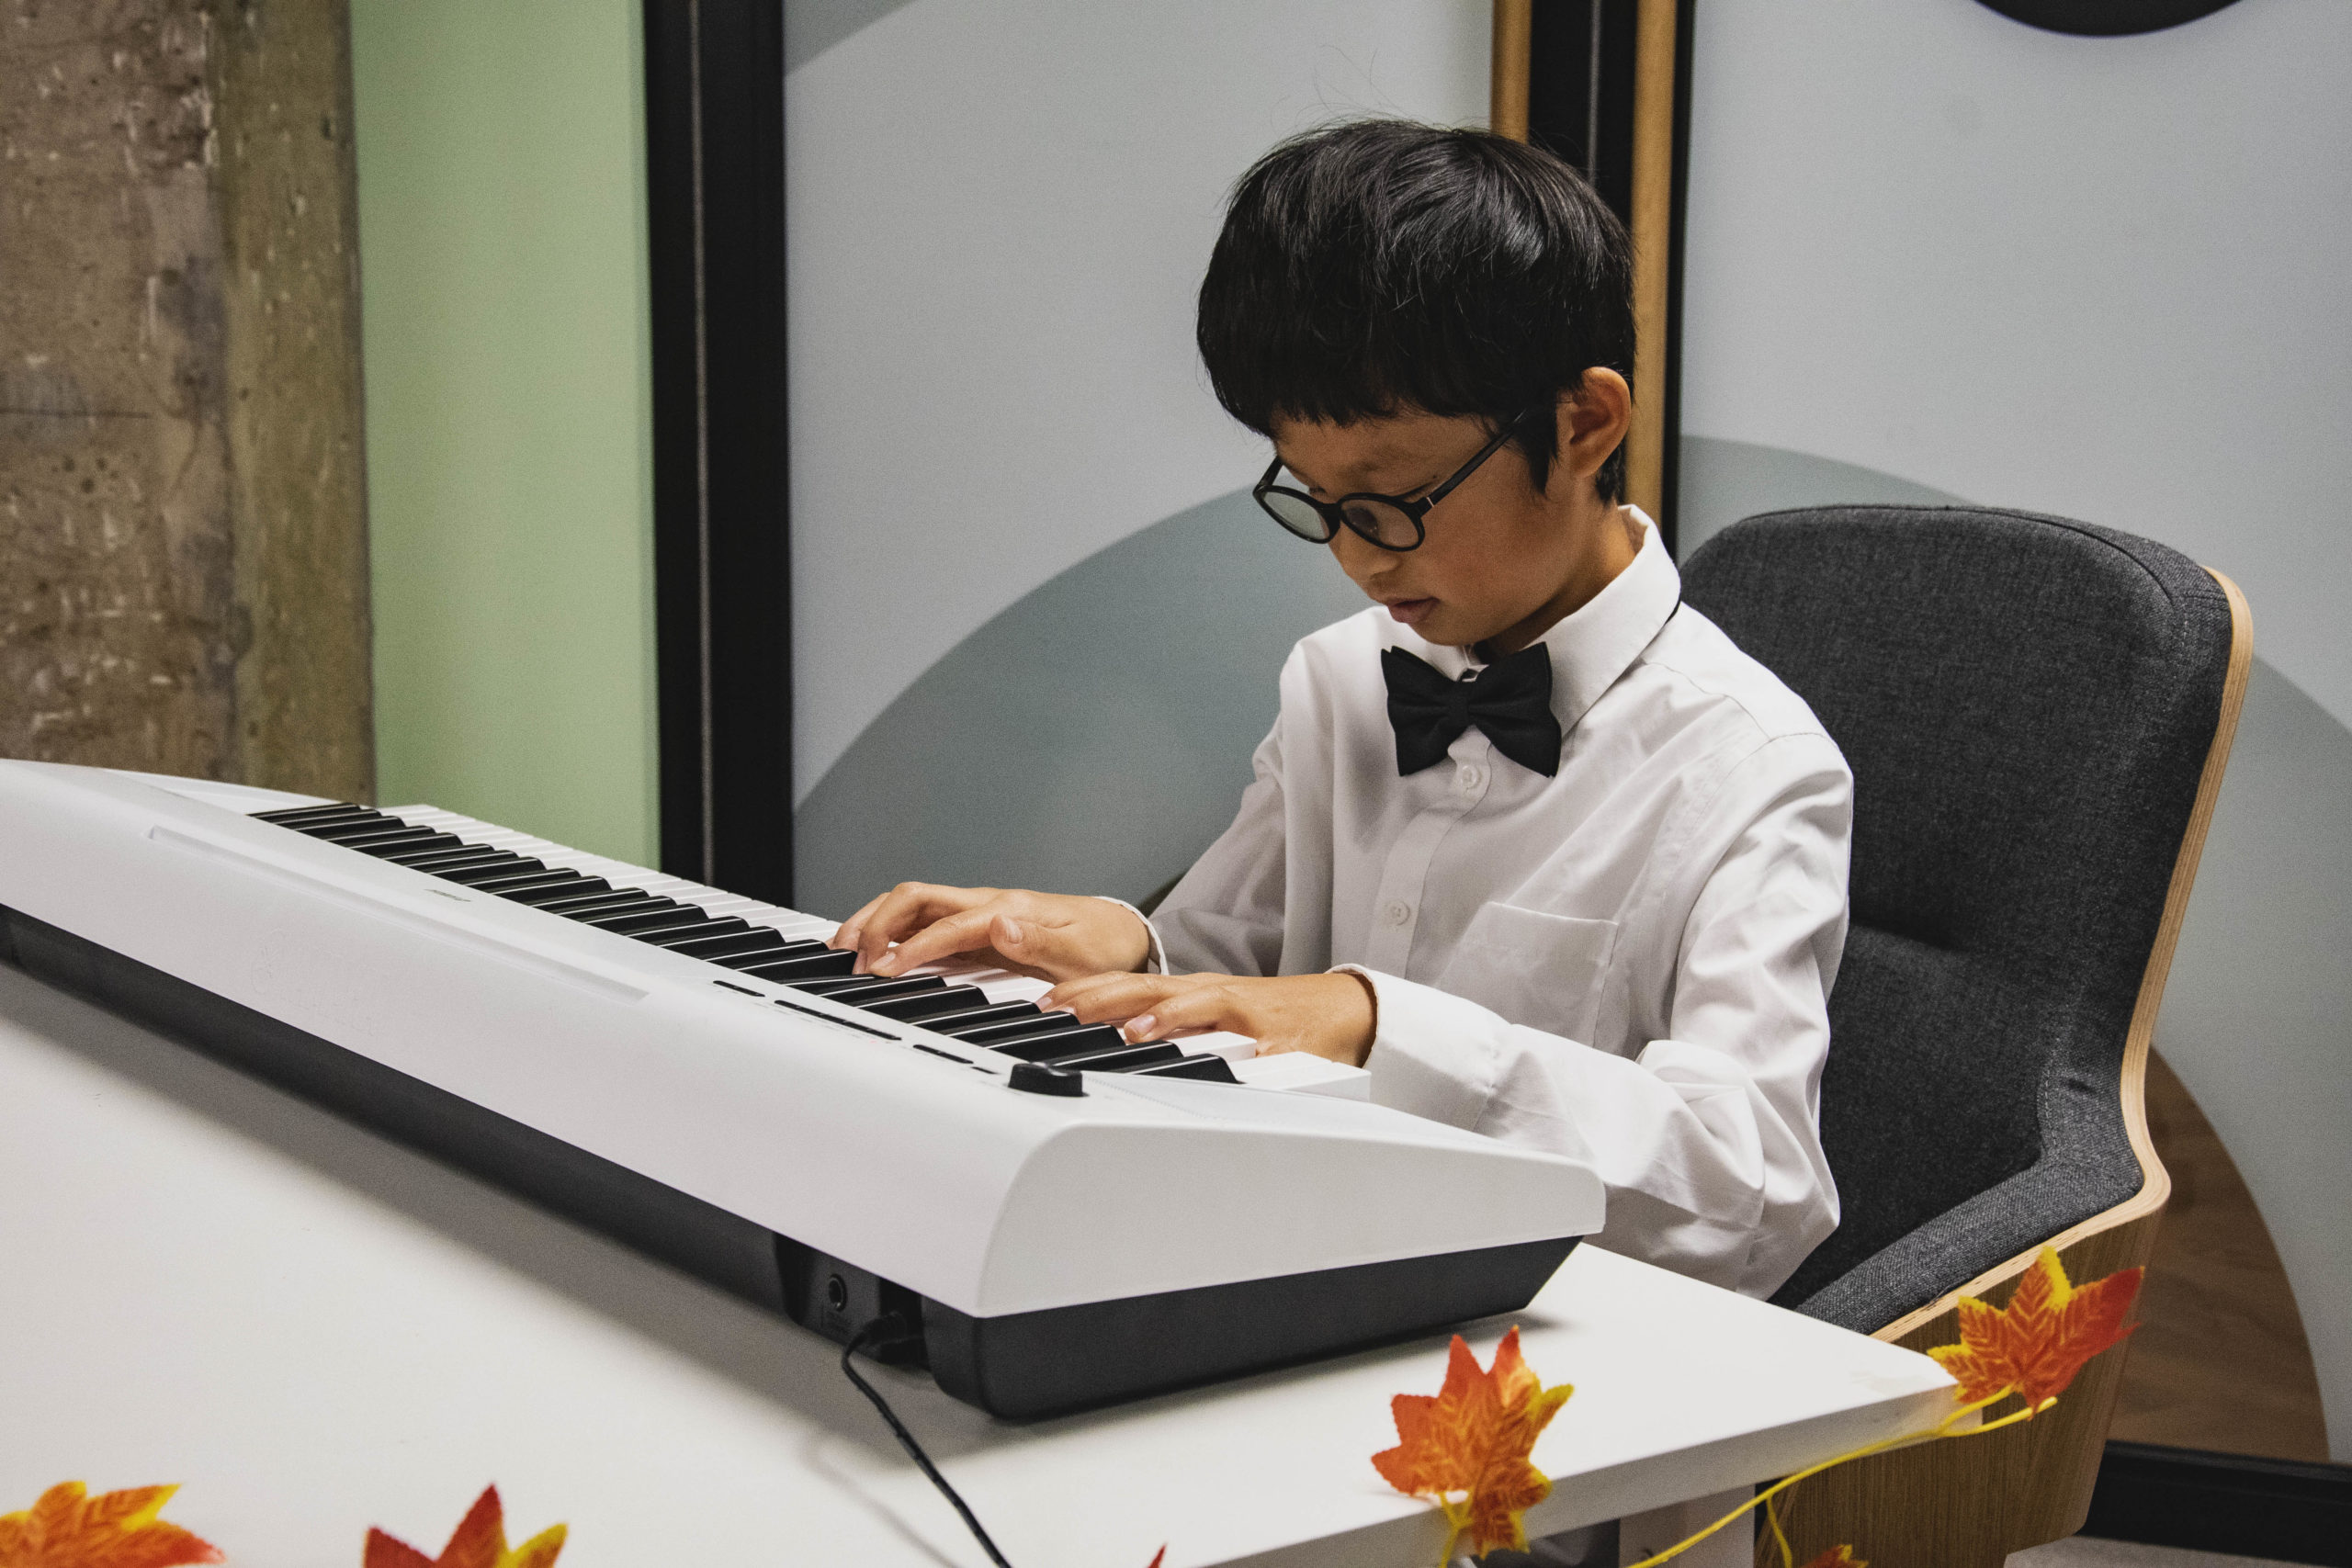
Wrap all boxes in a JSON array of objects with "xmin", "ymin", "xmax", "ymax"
[{"xmin": 831, "ymin": 882, "xmax": 1152, "ymax": 980}]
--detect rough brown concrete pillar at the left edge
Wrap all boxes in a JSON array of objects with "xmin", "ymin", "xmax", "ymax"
[{"xmin": 0, "ymin": 0, "xmax": 374, "ymax": 799}]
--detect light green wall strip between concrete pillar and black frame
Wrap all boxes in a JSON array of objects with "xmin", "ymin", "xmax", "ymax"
[{"xmin": 350, "ymin": 0, "xmax": 656, "ymax": 863}]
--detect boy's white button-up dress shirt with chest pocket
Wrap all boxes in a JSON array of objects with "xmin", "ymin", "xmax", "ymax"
[{"xmin": 1155, "ymin": 513, "xmax": 1853, "ymax": 1295}]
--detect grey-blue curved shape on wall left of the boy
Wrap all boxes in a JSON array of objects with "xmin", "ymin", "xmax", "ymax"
[{"xmin": 795, "ymin": 491, "xmax": 1364, "ymax": 917}]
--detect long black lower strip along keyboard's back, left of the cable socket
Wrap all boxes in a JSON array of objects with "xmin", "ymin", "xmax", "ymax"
[{"xmin": 0, "ymin": 908, "xmax": 786, "ymax": 1314}]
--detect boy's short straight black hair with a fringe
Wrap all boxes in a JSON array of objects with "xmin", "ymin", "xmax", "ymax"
[{"xmin": 1197, "ymin": 120, "xmax": 1634, "ymax": 501}]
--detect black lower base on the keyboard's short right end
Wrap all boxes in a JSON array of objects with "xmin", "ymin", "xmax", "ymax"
[{"xmin": 922, "ymin": 1236, "xmax": 1578, "ymax": 1420}]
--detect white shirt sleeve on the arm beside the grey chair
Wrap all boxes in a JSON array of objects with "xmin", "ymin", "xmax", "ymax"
[{"xmin": 1357, "ymin": 736, "xmax": 1853, "ymax": 1295}]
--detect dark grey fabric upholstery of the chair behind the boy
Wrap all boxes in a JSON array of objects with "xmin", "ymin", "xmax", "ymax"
[{"xmin": 1684, "ymin": 505, "xmax": 2232, "ymax": 1333}]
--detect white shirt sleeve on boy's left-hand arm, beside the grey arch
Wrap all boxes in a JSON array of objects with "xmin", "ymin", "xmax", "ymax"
[{"xmin": 1150, "ymin": 727, "xmax": 1286, "ymax": 976}]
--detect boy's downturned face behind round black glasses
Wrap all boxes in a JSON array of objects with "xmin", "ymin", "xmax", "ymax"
[{"xmin": 1275, "ymin": 400, "xmax": 1637, "ymax": 656}]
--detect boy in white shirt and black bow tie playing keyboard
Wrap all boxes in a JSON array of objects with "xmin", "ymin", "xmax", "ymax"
[{"xmin": 832, "ymin": 122, "xmax": 1851, "ymax": 1295}]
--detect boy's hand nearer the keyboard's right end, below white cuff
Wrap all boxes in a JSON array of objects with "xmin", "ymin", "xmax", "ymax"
[{"xmin": 1037, "ymin": 971, "xmax": 1376, "ymax": 1067}]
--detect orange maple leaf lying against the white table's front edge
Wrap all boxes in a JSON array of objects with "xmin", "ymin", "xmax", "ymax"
[{"xmin": 1371, "ymin": 1328, "xmax": 1576, "ymax": 1559}]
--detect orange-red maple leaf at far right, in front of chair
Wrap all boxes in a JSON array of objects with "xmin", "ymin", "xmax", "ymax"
[{"xmin": 1927, "ymin": 1246, "xmax": 2141, "ymax": 1413}]
